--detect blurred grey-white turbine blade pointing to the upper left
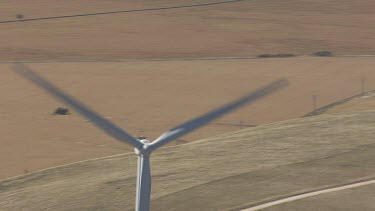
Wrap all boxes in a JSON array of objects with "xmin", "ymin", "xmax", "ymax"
[{"xmin": 11, "ymin": 64, "xmax": 143, "ymax": 149}]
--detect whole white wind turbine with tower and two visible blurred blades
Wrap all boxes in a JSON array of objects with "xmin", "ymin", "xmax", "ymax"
[{"xmin": 11, "ymin": 63, "xmax": 288, "ymax": 211}]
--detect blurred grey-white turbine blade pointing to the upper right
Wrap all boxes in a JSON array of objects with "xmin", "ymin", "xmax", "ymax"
[{"xmin": 148, "ymin": 79, "xmax": 288, "ymax": 151}]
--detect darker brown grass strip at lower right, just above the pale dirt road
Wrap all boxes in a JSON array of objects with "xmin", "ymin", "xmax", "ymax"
[{"xmin": 153, "ymin": 145, "xmax": 375, "ymax": 210}]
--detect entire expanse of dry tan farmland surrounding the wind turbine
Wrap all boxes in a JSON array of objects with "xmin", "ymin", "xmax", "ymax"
[{"xmin": 0, "ymin": 0, "xmax": 375, "ymax": 210}]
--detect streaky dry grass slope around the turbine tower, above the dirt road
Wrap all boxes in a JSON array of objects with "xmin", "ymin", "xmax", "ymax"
[{"xmin": 0, "ymin": 111, "xmax": 375, "ymax": 210}]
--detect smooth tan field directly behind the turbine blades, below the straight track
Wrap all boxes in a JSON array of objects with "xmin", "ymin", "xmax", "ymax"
[{"xmin": 0, "ymin": 57, "xmax": 375, "ymax": 178}]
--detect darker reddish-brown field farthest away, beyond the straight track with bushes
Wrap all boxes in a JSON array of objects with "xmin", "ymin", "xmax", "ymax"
[{"xmin": 0, "ymin": 0, "xmax": 375, "ymax": 61}]
